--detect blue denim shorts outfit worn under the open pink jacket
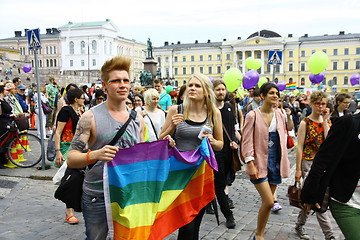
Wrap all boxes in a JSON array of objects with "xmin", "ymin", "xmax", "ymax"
[{"xmin": 250, "ymin": 132, "xmax": 281, "ymax": 185}]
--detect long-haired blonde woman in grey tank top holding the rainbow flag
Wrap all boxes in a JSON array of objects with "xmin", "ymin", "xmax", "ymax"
[{"xmin": 159, "ymin": 74, "xmax": 223, "ymax": 240}]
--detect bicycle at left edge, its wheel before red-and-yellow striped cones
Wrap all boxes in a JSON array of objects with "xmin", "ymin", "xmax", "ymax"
[{"xmin": 0, "ymin": 122, "xmax": 42, "ymax": 168}]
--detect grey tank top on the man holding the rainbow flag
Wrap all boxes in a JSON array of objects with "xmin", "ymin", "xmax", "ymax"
[{"xmin": 83, "ymin": 102, "xmax": 140, "ymax": 197}]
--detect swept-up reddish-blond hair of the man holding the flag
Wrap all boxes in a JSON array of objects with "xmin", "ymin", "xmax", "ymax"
[{"xmin": 101, "ymin": 56, "xmax": 131, "ymax": 82}]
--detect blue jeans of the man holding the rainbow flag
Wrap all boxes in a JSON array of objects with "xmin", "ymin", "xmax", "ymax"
[{"xmin": 81, "ymin": 192, "xmax": 108, "ymax": 240}]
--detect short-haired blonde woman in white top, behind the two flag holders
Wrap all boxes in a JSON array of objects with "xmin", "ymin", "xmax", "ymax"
[{"xmin": 137, "ymin": 88, "xmax": 165, "ymax": 142}]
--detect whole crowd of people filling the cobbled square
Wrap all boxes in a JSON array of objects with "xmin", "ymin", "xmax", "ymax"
[{"xmin": 0, "ymin": 56, "xmax": 360, "ymax": 240}]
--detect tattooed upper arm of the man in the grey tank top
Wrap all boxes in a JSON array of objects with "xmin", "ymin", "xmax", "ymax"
[{"xmin": 70, "ymin": 114, "xmax": 93, "ymax": 152}]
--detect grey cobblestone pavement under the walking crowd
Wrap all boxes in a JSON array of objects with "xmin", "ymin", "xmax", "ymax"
[{"xmin": 0, "ymin": 152, "xmax": 344, "ymax": 240}]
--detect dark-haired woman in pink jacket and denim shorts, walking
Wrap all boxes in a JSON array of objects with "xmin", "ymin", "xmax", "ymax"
[{"xmin": 241, "ymin": 83, "xmax": 293, "ymax": 240}]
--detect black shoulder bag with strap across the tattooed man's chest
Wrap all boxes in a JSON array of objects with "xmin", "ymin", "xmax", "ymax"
[{"xmin": 54, "ymin": 109, "xmax": 136, "ymax": 212}]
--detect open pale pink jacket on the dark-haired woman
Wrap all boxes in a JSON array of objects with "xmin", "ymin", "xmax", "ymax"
[{"xmin": 241, "ymin": 108, "xmax": 290, "ymax": 178}]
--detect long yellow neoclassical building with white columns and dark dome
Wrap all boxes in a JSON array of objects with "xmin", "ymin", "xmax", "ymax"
[{"xmin": 154, "ymin": 30, "xmax": 360, "ymax": 92}]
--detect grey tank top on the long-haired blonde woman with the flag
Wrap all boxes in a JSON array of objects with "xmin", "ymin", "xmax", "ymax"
[{"xmin": 174, "ymin": 105, "xmax": 213, "ymax": 152}]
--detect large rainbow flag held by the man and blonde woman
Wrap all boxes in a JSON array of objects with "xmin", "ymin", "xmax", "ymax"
[{"xmin": 104, "ymin": 138, "xmax": 217, "ymax": 240}]
